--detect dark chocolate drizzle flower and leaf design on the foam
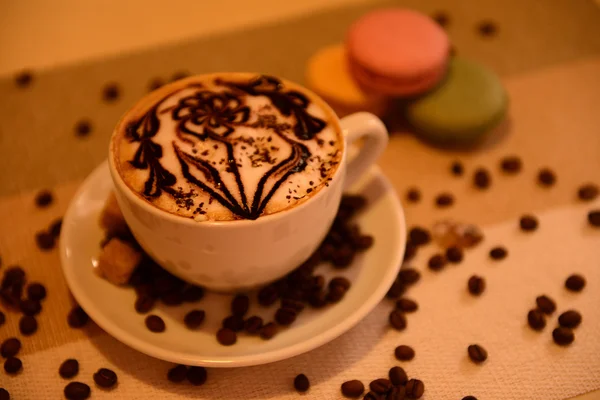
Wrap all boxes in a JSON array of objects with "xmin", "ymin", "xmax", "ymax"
[{"xmin": 125, "ymin": 76, "xmax": 327, "ymax": 219}]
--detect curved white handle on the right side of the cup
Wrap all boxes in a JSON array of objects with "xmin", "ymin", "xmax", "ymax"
[{"xmin": 340, "ymin": 112, "xmax": 388, "ymax": 190}]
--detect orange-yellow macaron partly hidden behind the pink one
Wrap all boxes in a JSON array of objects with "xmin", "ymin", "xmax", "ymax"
[{"xmin": 306, "ymin": 44, "xmax": 387, "ymax": 117}]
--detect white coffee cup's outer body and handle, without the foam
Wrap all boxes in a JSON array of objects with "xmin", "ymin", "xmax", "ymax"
[{"xmin": 109, "ymin": 74, "xmax": 388, "ymax": 291}]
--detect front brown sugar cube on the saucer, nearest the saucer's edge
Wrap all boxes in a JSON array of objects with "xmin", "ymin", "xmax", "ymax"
[{"xmin": 98, "ymin": 238, "xmax": 142, "ymax": 285}]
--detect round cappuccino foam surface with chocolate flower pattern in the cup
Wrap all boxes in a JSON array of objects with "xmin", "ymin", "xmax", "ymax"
[{"xmin": 111, "ymin": 74, "xmax": 344, "ymax": 221}]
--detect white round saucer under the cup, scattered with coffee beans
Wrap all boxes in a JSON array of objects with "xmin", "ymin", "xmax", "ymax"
[{"xmin": 60, "ymin": 162, "xmax": 406, "ymax": 367}]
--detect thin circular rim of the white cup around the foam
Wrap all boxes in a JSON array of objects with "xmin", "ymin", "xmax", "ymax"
[{"xmin": 108, "ymin": 72, "xmax": 347, "ymax": 228}]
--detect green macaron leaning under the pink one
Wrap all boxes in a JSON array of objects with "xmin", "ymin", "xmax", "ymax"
[{"xmin": 406, "ymin": 57, "xmax": 508, "ymax": 145}]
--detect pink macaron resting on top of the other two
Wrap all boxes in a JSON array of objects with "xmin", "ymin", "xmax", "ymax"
[{"xmin": 346, "ymin": 8, "xmax": 450, "ymax": 96}]
